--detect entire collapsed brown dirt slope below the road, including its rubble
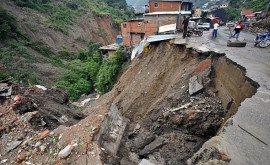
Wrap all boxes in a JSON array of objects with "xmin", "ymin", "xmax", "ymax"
[{"xmin": 0, "ymin": 42, "xmax": 256, "ymax": 165}]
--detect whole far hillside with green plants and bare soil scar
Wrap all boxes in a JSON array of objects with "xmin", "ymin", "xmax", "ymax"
[{"xmin": 0, "ymin": 0, "xmax": 133, "ymax": 99}]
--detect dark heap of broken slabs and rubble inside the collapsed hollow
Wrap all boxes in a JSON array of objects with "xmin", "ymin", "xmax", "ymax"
[{"xmin": 107, "ymin": 59, "xmax": 226, "ymax": 165}]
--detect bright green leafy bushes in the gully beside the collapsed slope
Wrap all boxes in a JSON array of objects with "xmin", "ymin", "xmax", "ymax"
[{"xmin": 55, "ymin": 46, "xmax": 125, "ymax": 100}]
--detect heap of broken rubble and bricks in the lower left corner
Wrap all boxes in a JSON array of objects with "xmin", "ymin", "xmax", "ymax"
[{"xmin": 0, "ymin": 82, "xmax": 84, "ymax": 164}]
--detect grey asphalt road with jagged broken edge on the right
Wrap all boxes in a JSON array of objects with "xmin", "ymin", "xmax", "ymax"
[{"xmin": 203, "ymin": 27, "xmax": 270, "ymax": 165}]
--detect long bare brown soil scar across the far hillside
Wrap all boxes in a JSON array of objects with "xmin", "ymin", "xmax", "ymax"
[{"xmin": 0, "ymin": 1, "xmax": 120, "ymax": 54}]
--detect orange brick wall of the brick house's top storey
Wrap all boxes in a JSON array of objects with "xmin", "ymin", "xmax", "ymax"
[{"xmin": 149, "ymin": 1, "xmax": 181, "ymax": 13}]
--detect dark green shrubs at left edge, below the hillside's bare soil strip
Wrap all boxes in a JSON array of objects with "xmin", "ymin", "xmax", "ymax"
[{"xmin": 0, "ymin": 8, "xmax": 63, "ymax": 84}]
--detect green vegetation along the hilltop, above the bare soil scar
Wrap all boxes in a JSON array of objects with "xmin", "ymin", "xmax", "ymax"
[{"xmin": 13, "ymin": 0, "xmax": 134, "ymax": 35}]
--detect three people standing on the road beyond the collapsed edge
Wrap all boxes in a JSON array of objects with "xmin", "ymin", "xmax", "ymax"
[{"xmin": 182, "ymin": 16, "xmax": 244, "ymax": 40}]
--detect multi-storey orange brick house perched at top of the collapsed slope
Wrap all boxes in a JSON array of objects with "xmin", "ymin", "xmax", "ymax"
[{"xmin": 121, "ymin": 0, "xmax": 193, "ymax": 47}]
